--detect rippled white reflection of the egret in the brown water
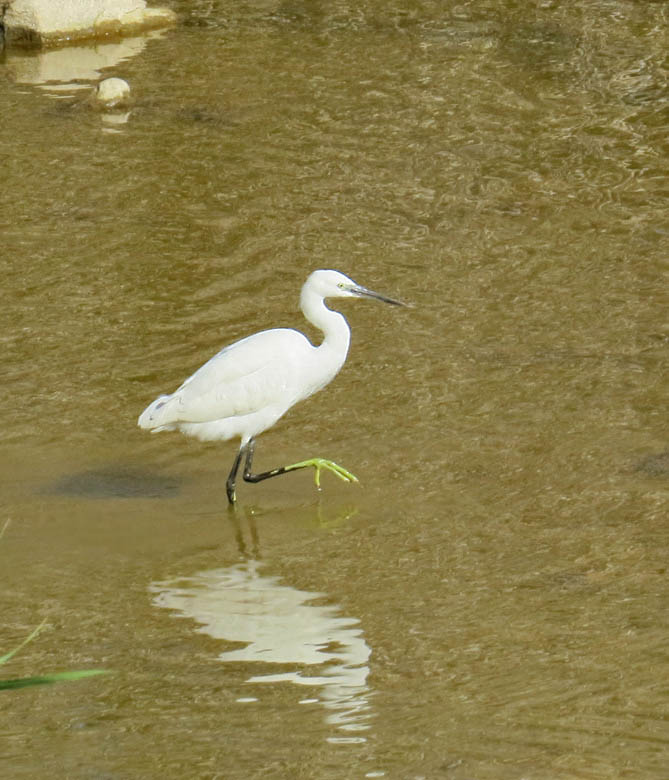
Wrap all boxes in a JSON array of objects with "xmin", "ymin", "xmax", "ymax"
[{"xmin": 149, "ymin": 506, "xmax": 372, "ymax": 744}]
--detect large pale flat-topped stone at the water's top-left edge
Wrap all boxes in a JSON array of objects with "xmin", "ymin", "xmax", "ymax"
[{"xmin": 0, "ymin": 0, "xmax": 176, "ymax": 44}]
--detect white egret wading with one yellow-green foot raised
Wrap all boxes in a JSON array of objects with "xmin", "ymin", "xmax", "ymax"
[{"xmin": 138, "ymin": 270, "xmax": 404, "ymax": 504}]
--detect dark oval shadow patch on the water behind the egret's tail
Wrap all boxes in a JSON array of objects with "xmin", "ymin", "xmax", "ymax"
[{"xmin": 40, "ymin": 465, "xmax": 181, "ymax": 498}]
